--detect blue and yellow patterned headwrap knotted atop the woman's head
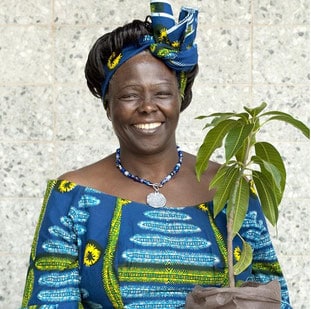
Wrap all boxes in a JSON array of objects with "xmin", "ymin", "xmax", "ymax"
[{"xmin": 101, "ymin": 0, "xmax": 198, "ymax": 98}]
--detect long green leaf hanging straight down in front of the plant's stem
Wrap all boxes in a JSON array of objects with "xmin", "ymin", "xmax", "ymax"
[{"xmin": 227, "ymin": 175, "xmax": 249, "ymax": 237}]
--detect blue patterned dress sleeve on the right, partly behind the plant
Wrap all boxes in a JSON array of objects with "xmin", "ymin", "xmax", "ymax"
[{"xmin": 240, "ymin": 195, "xmax": 292, "ymax": 309}]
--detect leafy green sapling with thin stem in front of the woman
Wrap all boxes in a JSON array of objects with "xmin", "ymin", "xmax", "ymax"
[{"xmin": 186, "ymin": 102, "xmax": 310, "ymax": 308}]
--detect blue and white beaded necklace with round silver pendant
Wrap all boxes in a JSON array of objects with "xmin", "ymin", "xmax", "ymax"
[{"xmin": 116, "ymin": 146, "xmax": 183, "ymax": 208}]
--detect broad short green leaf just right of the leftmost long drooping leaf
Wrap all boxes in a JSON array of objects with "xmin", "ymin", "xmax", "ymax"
[{"xmin": 225, "ymin": 124, "xmax": 254, "ymax": 161}]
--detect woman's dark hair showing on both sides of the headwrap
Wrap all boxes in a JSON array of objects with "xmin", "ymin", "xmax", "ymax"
[{"xmin": 84, "ymin": 16, "xmax": 198, "ymax": 111}]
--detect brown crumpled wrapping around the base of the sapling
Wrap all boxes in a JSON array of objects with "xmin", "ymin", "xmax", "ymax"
[{"xmin": 185, "ymin": 280, "xmax": 281, "ymax": 309}]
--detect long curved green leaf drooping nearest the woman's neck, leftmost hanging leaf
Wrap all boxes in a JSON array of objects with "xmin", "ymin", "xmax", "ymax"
[{"xmin": 195, "ymin": 119, "xmax": 236, "ymax": 180}]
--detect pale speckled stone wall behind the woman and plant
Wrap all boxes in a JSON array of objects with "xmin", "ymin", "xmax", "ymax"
[{"xmin": 0, "ymin": 0, "xmax": 310, "ymax": 309}]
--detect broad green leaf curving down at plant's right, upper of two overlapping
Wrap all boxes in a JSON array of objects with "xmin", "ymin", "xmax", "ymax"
[{"xmin": 255, "ymin": 142, "xmax": 286, "ymax": 203}]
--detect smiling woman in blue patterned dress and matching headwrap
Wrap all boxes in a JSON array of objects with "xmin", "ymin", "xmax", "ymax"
[{"xmin": 22, "ymin": 2, "xmax": 289, "ymax": 309}]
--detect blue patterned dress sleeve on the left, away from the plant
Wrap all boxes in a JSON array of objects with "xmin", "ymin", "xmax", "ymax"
[{"xmin": 21, "ymin": 180, "xmax": 83, "ymax": 309}]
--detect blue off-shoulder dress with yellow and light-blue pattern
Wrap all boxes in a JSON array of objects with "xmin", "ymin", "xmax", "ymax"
[{"xmin": 22, "ymin": 180, "xmax": 291, "ymax": 309}]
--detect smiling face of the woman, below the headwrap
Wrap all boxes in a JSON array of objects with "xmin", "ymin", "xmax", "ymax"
[{"xmin": 107, "ymin": 52, "xmax": 181, "ymax": 154}]
